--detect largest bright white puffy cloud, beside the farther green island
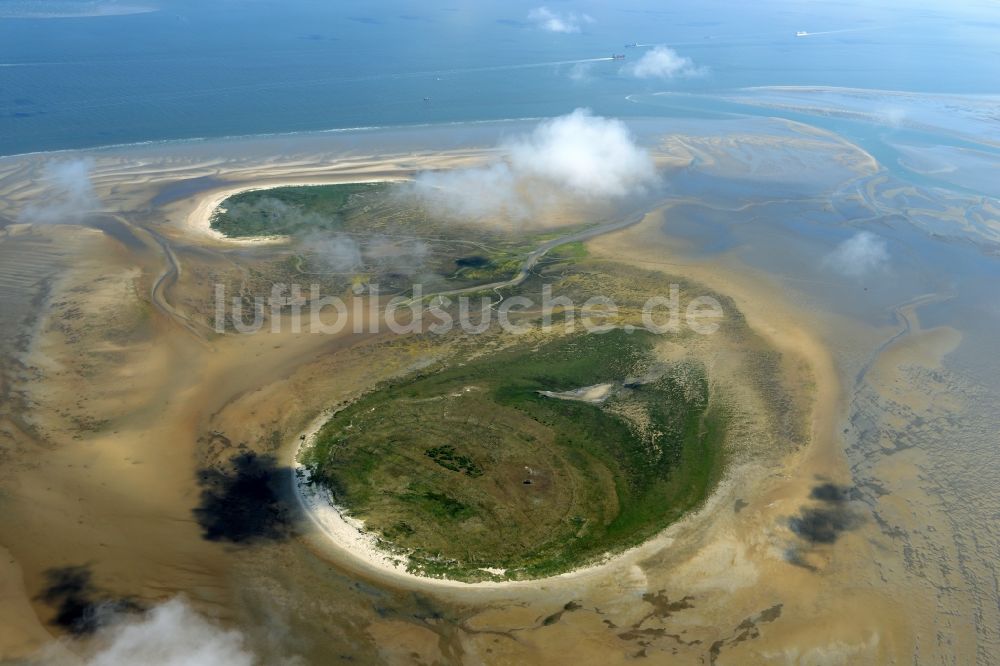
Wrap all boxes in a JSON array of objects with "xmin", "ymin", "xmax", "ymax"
[{"xmin": 414, "ymin": 109, "xmax": 657, "ymax": 220}]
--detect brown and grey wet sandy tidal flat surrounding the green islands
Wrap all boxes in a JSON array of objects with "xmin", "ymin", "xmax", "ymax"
[{"xmin": 0, "ymin": 114, "xmax": 1000, "ymax": 664}]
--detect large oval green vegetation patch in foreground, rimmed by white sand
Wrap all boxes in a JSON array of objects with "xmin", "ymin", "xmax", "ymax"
[{"xmin": 303, "ymin": 330, "xmax": 726, "ymax": 580}]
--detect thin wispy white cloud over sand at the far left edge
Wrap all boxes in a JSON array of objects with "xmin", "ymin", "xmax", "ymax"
[{"xmin": 18, "ymin": 159, "xmax": 100, "ymax": 224}]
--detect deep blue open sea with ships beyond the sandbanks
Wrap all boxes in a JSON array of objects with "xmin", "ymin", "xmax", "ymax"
[{"xmin": 0, "ymin": 0, "xmax": 1000, "ymax": 155}]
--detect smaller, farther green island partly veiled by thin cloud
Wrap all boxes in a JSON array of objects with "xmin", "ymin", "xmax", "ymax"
[{"xmin": 210, "ymin": 183, "xmax": 551, "ymax": 293}]
